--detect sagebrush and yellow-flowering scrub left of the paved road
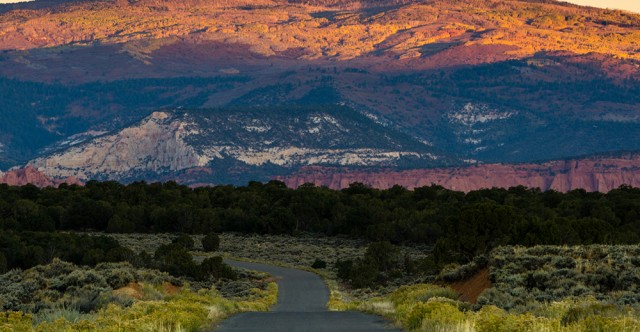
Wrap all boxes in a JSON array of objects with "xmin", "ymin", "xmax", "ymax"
[{"xmin": 0, "ymin": 259, "xmax": 277, "ymax": 331}]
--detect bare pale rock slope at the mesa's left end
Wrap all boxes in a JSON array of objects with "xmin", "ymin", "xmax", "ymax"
[{"xmin": 29, "ymin": 112, "xmax": 201, "ymax": 180}]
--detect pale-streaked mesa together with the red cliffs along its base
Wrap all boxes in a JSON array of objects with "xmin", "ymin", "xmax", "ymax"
[{"xmin": 8, "ymin": 106, "xmax": 640, "ymax": 192}]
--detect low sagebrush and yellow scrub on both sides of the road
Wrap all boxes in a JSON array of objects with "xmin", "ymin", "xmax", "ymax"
[{"xmin": 5, "ymin": 230, "xmax": 640, "ymax": 331}]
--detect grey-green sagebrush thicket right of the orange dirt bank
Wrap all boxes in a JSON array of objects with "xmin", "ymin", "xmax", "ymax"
[{"xmin": 478, "ymin": 245, "xmax": 640, "ymax": 312}]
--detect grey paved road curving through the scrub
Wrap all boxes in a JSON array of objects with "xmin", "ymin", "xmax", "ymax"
[{"xmin": 215, "ymin": 261, "xmax": 399, "ymax": 332}]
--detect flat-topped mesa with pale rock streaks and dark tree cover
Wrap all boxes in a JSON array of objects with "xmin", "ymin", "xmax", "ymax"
[{"xmin": 28, "ymin": 107, "xmax": 446, "ymax": 183}]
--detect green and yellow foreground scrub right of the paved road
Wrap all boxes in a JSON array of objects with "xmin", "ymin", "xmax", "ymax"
[{"xmin": 344, "ymin": 245, "xmax": 640, "ymax": 331}]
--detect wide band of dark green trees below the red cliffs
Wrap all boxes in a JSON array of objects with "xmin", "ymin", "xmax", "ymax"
[{"xmin": 0, "ymin": 181, "xmax": 640, "ymax": 265}]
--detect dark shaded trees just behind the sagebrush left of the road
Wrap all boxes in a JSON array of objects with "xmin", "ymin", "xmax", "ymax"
[{"xmin": 0, "ymin": 231, "xmax": 236, "ymax": 280}]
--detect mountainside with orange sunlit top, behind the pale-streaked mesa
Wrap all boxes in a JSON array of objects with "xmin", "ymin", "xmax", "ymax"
[{"xmin": 0, "ymin": 0, "xmax": 640, "ymax": 187}]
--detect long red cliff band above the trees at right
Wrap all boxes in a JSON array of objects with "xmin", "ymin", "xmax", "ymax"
[{"xmin": 279, "ymin": 154, "xmax": 640, "ymax": 192}]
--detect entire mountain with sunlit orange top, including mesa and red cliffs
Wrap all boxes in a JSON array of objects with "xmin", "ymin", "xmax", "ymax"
[{"xmin": 0, "ymin": 0, "xmax": 640, "ymax": 190}]
